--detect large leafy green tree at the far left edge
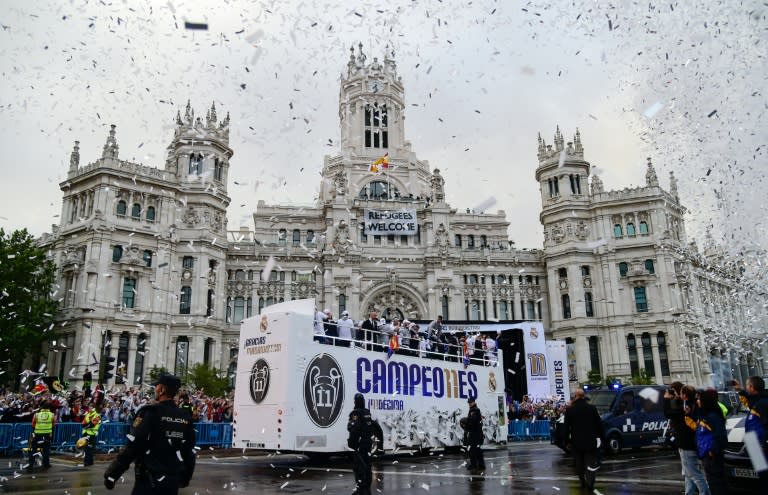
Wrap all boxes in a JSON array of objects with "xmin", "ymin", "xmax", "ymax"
[{"xmin": 0, "ymin": 229, "xmax": 61, "ymax": 387}]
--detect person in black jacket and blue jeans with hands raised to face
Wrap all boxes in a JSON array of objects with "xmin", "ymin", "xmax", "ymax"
[{"xmin": 664, "ymin": 382, "xmax": 709, "ymax": 495}]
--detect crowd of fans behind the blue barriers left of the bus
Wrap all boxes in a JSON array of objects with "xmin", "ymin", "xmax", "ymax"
[{"xmin": 0, "ymin": 386, "xmax": 233, "ymax": 423}]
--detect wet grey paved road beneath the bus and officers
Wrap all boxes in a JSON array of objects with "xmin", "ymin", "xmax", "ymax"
[{"xmin": 0, "ymin": 442, "xmax": 704, "ymax": 495}]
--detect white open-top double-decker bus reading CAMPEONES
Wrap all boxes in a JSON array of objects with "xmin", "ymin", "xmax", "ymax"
[{"xmin": 232, "ymin": 299, "xmax": 507, "ymax": 455}]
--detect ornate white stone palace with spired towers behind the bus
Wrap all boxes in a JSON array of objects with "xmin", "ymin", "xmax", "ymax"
[{"xmin": 41, "ymin": 46, "xmax": 760, "ymax": 392}]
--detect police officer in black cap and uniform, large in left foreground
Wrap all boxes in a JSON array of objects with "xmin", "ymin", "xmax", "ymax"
[{"xmin": 104, "ymin": 373, "xmax": 195, "ymax": 495}]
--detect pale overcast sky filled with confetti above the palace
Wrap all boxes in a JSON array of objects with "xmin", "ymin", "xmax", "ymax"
[{"xmin": 0, "ymin": 0, "xmax": 768, "ymax": 254}]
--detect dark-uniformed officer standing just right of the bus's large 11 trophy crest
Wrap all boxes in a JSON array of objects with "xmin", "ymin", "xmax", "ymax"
[{"xmin": 347, "ymin": 394, "xmax": 374, "ymax": 495}]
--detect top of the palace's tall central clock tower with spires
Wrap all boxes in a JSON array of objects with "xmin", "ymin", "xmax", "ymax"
[{"xmin": 339, "ymin": 43, "xmax": 405, "ymax": 157}]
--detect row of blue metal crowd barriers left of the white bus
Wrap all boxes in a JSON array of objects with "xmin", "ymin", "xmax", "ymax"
[{"xmin": 0, "ymin": 422, "xmax": 232, "ymax": 454}]
